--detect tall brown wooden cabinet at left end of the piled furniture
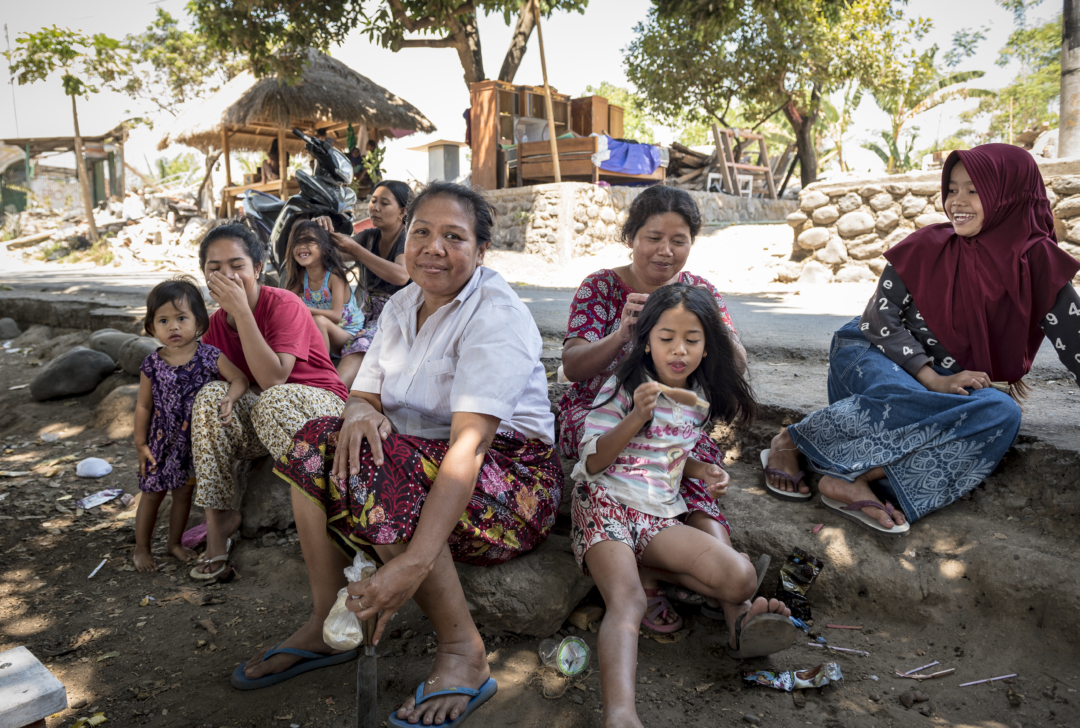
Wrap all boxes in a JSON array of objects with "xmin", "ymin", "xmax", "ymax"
[{"xmin": 469, "ymin": 81, "xmax": 570, "ymax": 190}]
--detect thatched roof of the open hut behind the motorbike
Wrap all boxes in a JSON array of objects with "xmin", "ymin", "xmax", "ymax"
[{"xmin": 158, "ymin": 51, "xmax": 435, "ymax": 152}]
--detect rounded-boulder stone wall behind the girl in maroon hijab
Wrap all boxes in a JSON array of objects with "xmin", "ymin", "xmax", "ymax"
[{"xmin": 777, "ymin": 154, "xmax": 1080, "ymax": 283}]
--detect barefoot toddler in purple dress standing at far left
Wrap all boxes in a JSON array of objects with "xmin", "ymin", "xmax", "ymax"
[{"xmin": 134, "ymin": 278, "xmax": 247, "ymax": 571}]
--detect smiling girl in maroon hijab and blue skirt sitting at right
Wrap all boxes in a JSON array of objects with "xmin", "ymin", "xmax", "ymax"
[{"xmin": 762, "ymin": 144, "xmax": 1080, "ymax": 535}]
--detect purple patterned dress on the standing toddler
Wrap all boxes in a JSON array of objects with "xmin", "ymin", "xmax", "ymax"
[{"xmin": 138, "ymin": 342, "xmax": 221, "ymax": 493}]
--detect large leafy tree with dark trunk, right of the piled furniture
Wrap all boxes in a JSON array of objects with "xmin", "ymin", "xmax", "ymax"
[{"xmin": 625, "ymin": 0, "xmax": 926, "ymax": 185}]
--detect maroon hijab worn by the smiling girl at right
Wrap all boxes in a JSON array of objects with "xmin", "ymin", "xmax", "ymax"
[{"xmin": 885, "ymin": 144, "xmax": 1080, "ymax": 382}]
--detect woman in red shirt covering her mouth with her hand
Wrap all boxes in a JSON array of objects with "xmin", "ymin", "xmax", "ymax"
[{"xmin": 191, "ymin": 224, "xmax": 349, "ymax": 579}]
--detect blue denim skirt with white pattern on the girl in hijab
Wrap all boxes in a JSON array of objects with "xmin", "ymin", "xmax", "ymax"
[{"xmin": 787, "ymin": 319, "xmax": 1021, "ymax": 523}]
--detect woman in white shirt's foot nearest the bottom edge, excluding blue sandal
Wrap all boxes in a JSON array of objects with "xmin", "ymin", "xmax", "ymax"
[{"xmin": 397, "ymin": 634, "xmax": 491, "ymax": 726}]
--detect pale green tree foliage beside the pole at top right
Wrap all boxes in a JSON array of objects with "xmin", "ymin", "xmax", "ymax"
[{"xmin": 959, "ymin": 4, "xmax": 1062, "ymax": 141}]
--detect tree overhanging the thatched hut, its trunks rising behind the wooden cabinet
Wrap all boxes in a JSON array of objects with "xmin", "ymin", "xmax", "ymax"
[{"xmin": 188, "ymin": 0, "xmax": 589, "ymax": 85}]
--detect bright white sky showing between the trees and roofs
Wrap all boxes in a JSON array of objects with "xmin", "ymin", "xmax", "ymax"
[{"xmin": 0, "ymin": 0, "xmax": 1059, "ymax": 180}]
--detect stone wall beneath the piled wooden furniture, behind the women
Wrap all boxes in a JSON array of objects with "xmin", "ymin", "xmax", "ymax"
[{"xmin": 487, "ymin": 183, "xmax": 798, "ymax": 262}]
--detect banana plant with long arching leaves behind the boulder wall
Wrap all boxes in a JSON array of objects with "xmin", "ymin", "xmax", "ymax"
[{"xmin": 867, "ymin": 31, "xmax": 996, "ymax": 174}]
